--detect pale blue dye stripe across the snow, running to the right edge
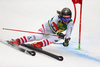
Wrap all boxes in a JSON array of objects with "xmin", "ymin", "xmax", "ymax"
[{"xmin": 59, "ymin": 46, "xmax": 100, "ymax": 62}]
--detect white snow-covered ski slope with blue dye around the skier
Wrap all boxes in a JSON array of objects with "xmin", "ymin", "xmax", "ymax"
[{"xmin": 0, "ymin": 0, "xmax": 100, "ymax": 67}]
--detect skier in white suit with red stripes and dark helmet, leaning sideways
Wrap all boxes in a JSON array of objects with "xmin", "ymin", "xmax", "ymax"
[{"xmin": 10, "ymin": 8, "xmax": 73, "ymax": 49}]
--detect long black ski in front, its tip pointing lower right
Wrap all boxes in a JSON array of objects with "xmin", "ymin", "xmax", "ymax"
[{"xmin": 21, "ymin": 44, "xmax": 63, "ymax": 61}]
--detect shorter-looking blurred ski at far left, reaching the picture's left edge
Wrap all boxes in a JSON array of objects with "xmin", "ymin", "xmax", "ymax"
[{"xmin": 0, "ymin": 40, "xmax": 36, "ymax": 56}]
